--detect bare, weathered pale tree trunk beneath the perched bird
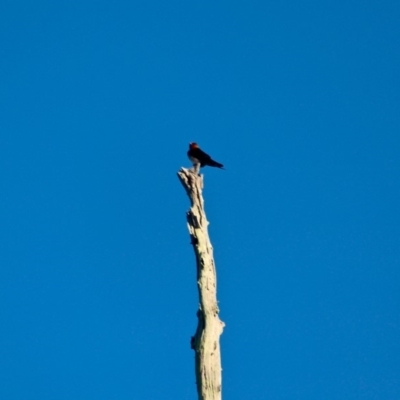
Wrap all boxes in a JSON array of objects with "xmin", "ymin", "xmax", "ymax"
[{"xmin": 178, "ymin": 168, "xmax": 225, "ymax": 400}]
